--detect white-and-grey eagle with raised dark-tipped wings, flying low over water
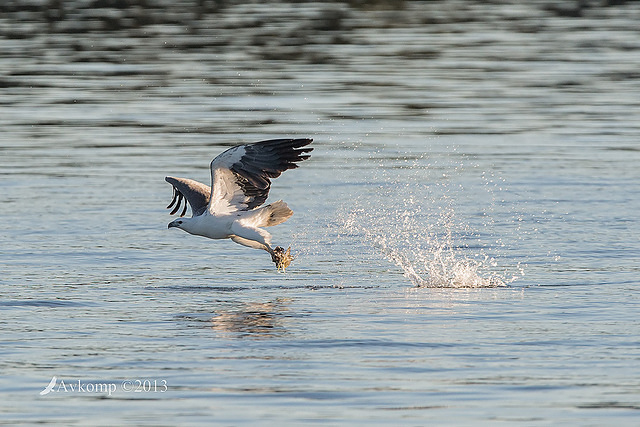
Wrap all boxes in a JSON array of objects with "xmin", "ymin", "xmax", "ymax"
[{"xmin": 165, "ymin": 138, "xmax": 313, "ymax": 271}]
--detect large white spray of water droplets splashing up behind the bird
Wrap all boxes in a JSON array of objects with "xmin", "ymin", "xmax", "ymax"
[{"xmin": 343, "ymin": 159, "xmax": 522, "ymax": 288}]
